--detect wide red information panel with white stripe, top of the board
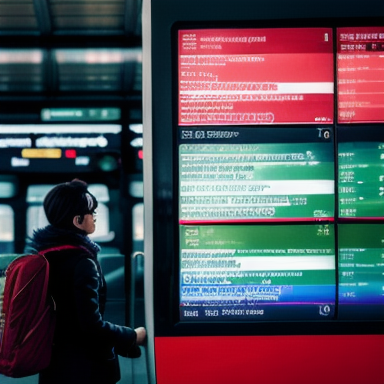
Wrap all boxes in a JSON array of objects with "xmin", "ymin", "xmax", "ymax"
[{"xmin": 178, "ymin": 28, "xmax": 334, "ymax": 125}]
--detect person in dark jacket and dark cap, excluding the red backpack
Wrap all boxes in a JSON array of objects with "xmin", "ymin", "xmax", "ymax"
[{"xmin": 25, "ymin": 179, "xmax": 146, "ymax": 384}]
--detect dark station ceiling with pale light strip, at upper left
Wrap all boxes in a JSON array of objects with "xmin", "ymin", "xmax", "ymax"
[{"xmin": 0, "ymin": 0, "xmax": 142, "ymax": 100}]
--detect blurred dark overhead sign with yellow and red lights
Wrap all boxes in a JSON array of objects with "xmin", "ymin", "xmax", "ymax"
[{"xmin": 0, "ymin": 124, "xmax": 122, "ymax": 172}]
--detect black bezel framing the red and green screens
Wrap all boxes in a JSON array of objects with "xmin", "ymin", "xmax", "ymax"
[{"xmin": 150, "ymin": 17, "xmax": 384, "ymax": 336}]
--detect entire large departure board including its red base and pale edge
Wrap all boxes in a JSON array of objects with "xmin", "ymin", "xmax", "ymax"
[{"xmin": 148, "ymin": 0, "xmax": 384, "ymax": 384}]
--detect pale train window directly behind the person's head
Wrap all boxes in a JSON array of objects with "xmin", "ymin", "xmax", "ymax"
[{"xmin": 27, "ymin": 184, "xmax": 118, "ymax": 253}]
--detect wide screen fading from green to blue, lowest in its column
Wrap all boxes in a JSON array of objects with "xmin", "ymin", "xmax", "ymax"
[{"xmin": 180, "ymin": 224, "xmax": 336, "ymax": 321}]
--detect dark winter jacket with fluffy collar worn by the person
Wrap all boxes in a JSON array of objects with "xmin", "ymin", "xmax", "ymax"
[{"xmin": 30, "ymin": 225, "xmax": 140, "ymax": 384}]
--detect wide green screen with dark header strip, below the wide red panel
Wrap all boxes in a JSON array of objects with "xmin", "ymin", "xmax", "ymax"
[{"xmin": 179, "ymin": 127, "xmax": 335, "ymax": 224}]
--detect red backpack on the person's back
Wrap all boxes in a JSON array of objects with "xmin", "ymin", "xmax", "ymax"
[{"xmin": 0, "ymin": 245, "xmax": 78, "ymax": 377}]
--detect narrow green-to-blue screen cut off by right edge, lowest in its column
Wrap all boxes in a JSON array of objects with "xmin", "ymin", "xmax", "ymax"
[{"xmin": 338, "ymin": 224, "xmax": 384, "ymax": 320}]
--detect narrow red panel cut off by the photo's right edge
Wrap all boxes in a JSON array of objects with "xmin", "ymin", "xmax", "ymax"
[{"xmin": 337, "ymin": 26, "xmax": 384, "ymax": 123}]
